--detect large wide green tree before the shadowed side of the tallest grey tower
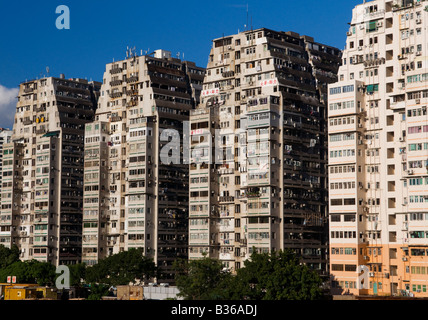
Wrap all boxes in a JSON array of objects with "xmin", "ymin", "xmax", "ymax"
[{"xmin": 229, "ymin": 250, "xmax": 322, "ymax": 300}]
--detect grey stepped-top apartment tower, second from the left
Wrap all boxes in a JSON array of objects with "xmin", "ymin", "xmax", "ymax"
[{"xmin": 83, "ymin": 50, "xmax": 205, "ymax": 282}]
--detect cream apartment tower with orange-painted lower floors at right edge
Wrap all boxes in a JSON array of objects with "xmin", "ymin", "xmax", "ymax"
[{"xmin": 329, "ymin": 0, "xmax": 428, "ymax": 297}]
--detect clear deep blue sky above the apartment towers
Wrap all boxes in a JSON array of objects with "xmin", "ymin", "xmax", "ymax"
[{"xmin": 0, "ymin": 0, "xmax": 363, "ymax": 126}]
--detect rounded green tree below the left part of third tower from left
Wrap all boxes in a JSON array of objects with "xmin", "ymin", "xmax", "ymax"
[{"xmin": 174, "ymin": 257, "xmax": 232, "ymax": 300}]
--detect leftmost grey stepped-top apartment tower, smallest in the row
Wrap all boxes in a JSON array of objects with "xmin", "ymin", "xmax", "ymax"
[{"xmin": 0, "ymin": 75, "xmax": 101, "ymax": 265}]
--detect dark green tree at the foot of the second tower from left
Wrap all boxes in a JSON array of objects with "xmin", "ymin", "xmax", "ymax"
[{"xmin": 85, "ymin": 248, "xmax": 156, "ymax": 286}]
